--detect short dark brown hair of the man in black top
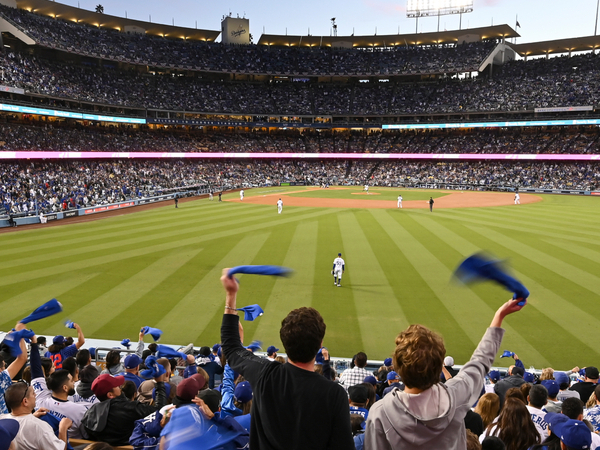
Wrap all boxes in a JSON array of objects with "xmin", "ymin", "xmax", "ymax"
[{"xmin": 279, "ymin": 307, "xmax": 327, "ymax": 363}]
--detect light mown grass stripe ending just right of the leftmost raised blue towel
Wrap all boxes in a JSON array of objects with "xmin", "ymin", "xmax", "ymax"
[{"xmin": 44, "ymin": 248, "xmax": 202, "ymax": 335}]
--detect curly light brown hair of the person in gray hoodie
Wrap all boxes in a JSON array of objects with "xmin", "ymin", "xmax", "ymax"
[{"xmin": 393, "ymin": 325, "xmax": 446, "ymax": 390}]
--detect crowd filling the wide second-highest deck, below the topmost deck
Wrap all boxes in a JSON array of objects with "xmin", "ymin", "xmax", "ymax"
[{"xmin": 2, "ymin": 51, "xmax": 600, "ymax": 115}]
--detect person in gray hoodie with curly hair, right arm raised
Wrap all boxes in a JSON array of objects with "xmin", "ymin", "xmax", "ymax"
[{"xmin": 364, "ymin": 299, "xmax": 523, "ymax": 450}]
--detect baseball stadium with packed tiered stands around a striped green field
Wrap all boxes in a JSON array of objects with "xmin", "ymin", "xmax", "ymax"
[{"xmin": 0, "ymin": 0, "xmax": 600, "ymax": 449}]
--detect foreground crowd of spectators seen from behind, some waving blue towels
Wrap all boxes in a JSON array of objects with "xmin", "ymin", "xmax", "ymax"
[{"xmin": 0, "ymin": 269, "xmax": 600, "ymax": 450}]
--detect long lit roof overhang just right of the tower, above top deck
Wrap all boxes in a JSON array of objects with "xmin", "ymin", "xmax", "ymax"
[{"xmin": 258, "ymin": 25, "xmax": 520, "ymax": 48}]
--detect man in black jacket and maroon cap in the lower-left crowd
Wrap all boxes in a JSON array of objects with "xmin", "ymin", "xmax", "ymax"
[{"xmin": 82, "ymin": 373, "xmax": 167, "ymax": 447}]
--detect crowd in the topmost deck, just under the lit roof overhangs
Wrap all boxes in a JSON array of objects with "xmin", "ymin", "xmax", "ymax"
[{"xmin": 0, "ymin": 6, "xmax": 495, "ymax": 75}]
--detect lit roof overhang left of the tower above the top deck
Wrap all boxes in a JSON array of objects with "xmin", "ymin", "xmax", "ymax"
[{"xmin": 16, "ymin": 0, "xmax": 221, "ymax": 42}]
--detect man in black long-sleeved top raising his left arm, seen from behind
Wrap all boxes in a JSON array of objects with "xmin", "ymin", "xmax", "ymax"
[{"xmin": 221, "ymin": 269, "xmax": 354, "ymax": 450}]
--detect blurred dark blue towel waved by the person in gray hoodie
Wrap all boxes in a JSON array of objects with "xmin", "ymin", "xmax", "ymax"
[{"xmin": 454, "ymin": 254, "xmax": 529, "ymax": 306}]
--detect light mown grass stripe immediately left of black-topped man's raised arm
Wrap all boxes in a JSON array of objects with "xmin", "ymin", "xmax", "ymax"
[{"xmin": 157, "ymin": 232, "xmax": 271, "ymax": 345}]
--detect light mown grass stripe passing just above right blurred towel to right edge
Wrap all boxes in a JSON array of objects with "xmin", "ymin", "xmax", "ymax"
[{"xmin": 468, "ymin": 226, "xmax": 600, "ymax": 295}]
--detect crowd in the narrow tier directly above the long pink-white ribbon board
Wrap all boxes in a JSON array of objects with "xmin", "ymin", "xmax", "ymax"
[{"xmin": 0, "ymin": 121, "xmax": 600, "ymax": 154}]
